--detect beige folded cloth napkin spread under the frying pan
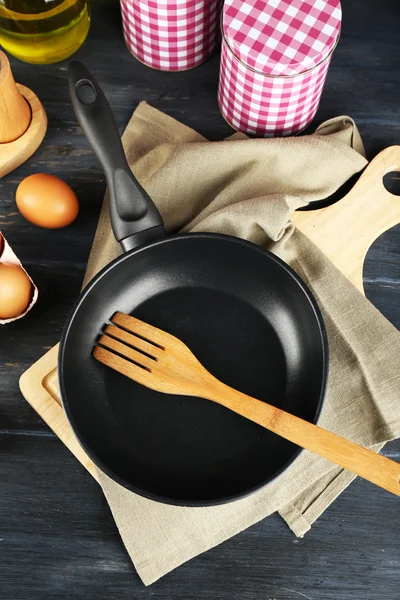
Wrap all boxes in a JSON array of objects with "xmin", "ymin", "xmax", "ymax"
[{"xmin": 77, "ymin": 103, "xmax": 400, "ymax": 585}]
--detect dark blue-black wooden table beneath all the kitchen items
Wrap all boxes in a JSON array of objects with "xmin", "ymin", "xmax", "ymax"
[{"xmin": 0, "ymin": 0, "xmax": 400, "ymax": 600}]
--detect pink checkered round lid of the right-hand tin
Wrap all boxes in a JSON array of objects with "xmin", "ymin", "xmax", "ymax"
[{"xmin": 222, "ymin": 0, "xmax": 342, "ymax": 76}]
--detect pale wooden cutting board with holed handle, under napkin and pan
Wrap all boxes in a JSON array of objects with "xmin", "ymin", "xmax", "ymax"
[{"xmin": 20, "ymin": 146, "xmax": 400, "ymax": 479}]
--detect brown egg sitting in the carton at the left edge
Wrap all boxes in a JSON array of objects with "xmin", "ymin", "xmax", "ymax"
[{"xmin": 0, "ymin": 263, "xmax": 32, "ymax": 319}]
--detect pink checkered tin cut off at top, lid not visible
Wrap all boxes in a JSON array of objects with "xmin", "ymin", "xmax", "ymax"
[{"xmin": 120, "ymin": 0, "xmax": 223, "ymax": 71}]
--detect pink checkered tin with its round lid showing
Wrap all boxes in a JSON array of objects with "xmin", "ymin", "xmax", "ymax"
[{"xmin": 218, "ymin": 0, "xmax": 342, "ymax": 137}]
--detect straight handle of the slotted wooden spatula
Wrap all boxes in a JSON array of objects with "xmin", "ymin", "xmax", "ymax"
[{"xmin": 208, "ymin": 382, "xmax": 400, "ymax": 496}]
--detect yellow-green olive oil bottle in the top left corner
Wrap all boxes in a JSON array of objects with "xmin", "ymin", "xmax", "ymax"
[{"xmin": 0, "ymin": 0, "xmax": 90, "ymax": 63}]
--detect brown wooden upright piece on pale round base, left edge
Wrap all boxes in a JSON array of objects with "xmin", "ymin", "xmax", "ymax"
[{"xmin": 0, "ymin": 50, "xmax": 31, "ymax": 144}]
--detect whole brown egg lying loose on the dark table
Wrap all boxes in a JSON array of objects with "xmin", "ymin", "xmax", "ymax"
[{"xmin": 16, "ymin": 173, "xmax": 79, "ymax": 229}]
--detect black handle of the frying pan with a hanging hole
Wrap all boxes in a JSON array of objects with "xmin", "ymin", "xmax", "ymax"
[{"xmin": 68, "ymin": 61, "xmax": 165, "ymax": 252}]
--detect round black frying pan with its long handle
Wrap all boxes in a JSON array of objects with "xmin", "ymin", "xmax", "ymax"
[{"xmin": 58, "ymin": 62, "xmax": 328, "ymax": 506}]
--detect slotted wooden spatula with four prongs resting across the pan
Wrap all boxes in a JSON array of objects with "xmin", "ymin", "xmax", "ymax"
[{"xmin": 93, "ymin": 313, "xmax": 400, "ymax": 496}]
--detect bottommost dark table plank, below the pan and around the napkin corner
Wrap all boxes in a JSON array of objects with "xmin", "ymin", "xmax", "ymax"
[{"xmin": 0, "ymin": 435, "xmax": 400, "ymax": 600}]
